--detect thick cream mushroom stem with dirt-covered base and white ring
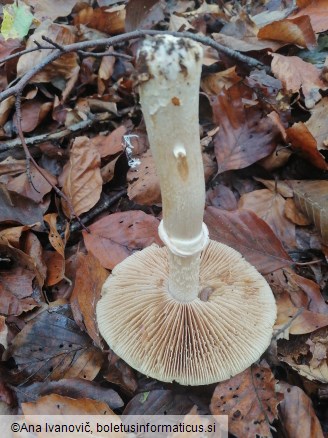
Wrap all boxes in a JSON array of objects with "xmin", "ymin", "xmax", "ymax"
[{"xmin": 138, "ymin": 35, "xmax": 208, "ymax": 302}]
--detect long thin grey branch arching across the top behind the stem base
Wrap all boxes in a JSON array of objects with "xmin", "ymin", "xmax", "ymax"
[{"xmin": 0, "ymin": 30, "xmax": 268, "ymax": 102}]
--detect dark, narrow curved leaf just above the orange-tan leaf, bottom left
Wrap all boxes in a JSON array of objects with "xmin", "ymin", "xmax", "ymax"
[{"xmin": 16, "ymin": 379, "xmax": 124, "ymax": 409}]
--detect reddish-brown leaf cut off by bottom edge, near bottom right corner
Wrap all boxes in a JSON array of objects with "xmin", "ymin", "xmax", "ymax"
[{"xmin": 278, "ymin": 381, "xmax": 324, "ymax": 438}]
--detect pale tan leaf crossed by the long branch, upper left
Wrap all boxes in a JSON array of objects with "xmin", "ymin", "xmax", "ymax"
[{"xmin": 17, "ymin": 20, "xmax": 78, "ymax": 83}]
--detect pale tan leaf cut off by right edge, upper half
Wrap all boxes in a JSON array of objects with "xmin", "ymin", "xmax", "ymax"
[{"xmin": 305, "ymin": 97, "xmax": 328, "ymax": 149}]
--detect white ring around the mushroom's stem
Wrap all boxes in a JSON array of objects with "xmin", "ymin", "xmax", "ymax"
[{"xmin": 158, "ymin": 220, "xmax": 210, "ymax": 257}]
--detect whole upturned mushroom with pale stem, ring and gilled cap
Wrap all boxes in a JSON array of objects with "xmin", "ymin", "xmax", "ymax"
[{"xmin": 97, "ymin": 35, "xmax": 276, "ymax": 385}]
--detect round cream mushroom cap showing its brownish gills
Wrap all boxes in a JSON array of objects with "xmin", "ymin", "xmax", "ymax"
[{"xmin": 97, "ymin": 240, "xmax": 276, "ymax": 385}]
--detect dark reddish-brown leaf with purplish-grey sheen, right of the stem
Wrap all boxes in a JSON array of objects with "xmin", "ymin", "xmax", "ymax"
[{"xmin": 212, "ymin": 84, "xmax": 278, "ymax": 173}]
